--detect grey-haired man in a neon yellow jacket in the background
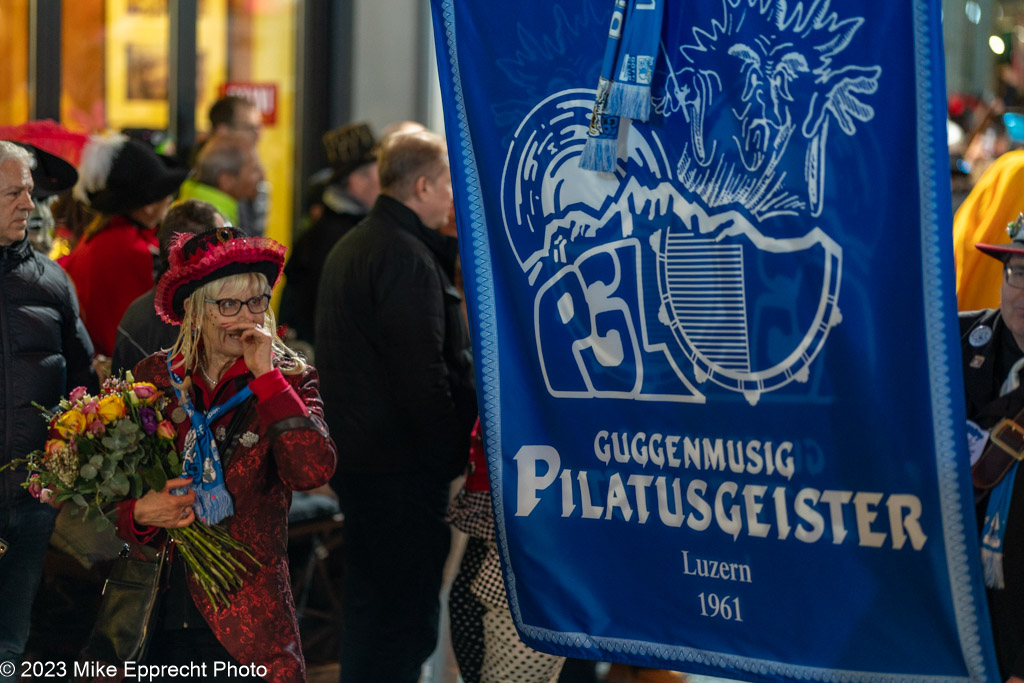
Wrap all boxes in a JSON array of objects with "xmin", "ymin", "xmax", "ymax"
[{"xmin": 178, "ymin": 132, "xmax": 263, "ymax": 234}]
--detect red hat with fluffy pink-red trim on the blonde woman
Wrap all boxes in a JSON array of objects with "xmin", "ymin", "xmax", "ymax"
[{"xmin": 156, "ymin": 227, "xmax": 287, "ymax": 325}]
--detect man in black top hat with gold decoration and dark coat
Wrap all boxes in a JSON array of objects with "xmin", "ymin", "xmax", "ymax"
[{"xmin": 281, "ymin": 123, "xmax": 381, "ymax": 343}]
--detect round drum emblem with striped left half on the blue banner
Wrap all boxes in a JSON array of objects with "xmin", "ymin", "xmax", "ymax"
[{"xmin": 657, "ymin": 215, "xmax": 843, "ymax": 403}]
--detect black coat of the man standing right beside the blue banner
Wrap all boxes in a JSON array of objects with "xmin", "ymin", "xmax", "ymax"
[{"xmin": 316, "ymin": 195, "xmax": 476, "ymax": 479}]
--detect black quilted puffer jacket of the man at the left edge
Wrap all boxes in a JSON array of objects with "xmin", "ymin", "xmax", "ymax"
[{"xmin": 0, "ymin": 240, "xmax": 97, "ymax": 505}]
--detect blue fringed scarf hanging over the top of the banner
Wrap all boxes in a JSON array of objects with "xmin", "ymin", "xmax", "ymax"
[{"xmin": 580, "ymin": 0, "xmax": 664, "ymax": 173}]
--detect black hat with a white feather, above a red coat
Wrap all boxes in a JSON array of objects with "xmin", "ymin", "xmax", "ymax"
[{"xmin": 75, "ymin": 135, "xmax": 188, "ymax": 216}]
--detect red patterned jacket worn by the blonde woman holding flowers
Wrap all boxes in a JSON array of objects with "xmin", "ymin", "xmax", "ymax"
[{"xmin": 118, "ymin": 353, "xmax": 336, "ymax": 683}]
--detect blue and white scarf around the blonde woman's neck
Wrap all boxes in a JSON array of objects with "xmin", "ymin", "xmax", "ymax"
[{"xmin": 167, "ymin": 356, "xmax": 253, "ymax": 524}]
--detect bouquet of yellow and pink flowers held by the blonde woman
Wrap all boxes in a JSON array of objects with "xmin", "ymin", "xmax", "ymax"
[{"xmin": 0, "ymin": 373, "xmax": 259, "ymax": 609}]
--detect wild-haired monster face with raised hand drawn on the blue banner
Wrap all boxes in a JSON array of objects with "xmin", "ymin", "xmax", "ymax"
[{"xmin": 654, "ymin": 0, "xmax": 882, "ymax": 220}]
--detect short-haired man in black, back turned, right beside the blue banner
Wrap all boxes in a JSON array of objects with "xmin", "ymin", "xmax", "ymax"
[{"xmin": 316, "ymin": 132, "xmax": 476, "ymax": 683}]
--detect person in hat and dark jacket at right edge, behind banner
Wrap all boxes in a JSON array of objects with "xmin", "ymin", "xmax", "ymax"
[{"xmin": 959, "ymin": 214, "xmax": 1024, "ymax": 682}]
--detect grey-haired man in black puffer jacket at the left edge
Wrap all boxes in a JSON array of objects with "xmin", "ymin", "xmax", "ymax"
[{"xmin": 0, "ymin": 141, "xmax": 96, "ymax": 681}]
